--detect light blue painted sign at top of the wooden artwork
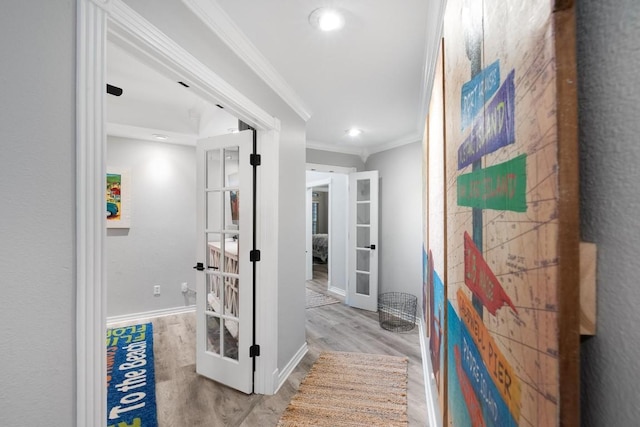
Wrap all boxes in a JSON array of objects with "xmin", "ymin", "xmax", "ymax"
[{"xmin": 460, "ymin": 60, "xmax": 500, "ymax": 130}]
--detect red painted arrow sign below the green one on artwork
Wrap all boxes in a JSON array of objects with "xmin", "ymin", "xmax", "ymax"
[{"xmin": 464, "ymin": 231, "xmax": 518, "ymax": 316}]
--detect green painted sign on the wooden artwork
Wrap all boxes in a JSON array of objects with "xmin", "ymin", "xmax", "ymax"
[{"xmin": 457, "ymin": 154, "xmax": 527, "ymax": 212}]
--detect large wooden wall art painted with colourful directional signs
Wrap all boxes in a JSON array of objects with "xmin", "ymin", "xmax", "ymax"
[{"xmin": 425, "ymin": 0, "xmax": 580, "ymax": 426}]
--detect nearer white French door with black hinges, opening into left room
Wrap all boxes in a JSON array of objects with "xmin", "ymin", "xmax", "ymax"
[{"xmin": 194, "ymin": 130, "xmax": 254, "ymax": 393}]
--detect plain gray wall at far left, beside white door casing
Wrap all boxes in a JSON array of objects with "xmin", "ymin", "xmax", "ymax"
[{"xmin": 0, "ymin": 0, "xmax": 76, "ymax": 427}]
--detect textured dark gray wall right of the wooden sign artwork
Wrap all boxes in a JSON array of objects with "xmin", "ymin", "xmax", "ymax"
[{"xmin": 576, "ymin": 0, "xmax": 640, "ymax": 426}]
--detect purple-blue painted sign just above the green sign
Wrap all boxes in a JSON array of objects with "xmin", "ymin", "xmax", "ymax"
[{"xmin": 458, "ymin": 70, "xmax": 515, "ymax": 170}]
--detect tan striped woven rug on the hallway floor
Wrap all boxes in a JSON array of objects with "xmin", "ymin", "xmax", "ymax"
[{"xmin": 278, "ymin": 352, "xmax": 408, "ymax": 427}]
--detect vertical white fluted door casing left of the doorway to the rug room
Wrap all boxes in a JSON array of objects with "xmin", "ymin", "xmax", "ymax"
[{"xmin": 76, "ymin": 0, "xmax": 107, "ymax": 426}]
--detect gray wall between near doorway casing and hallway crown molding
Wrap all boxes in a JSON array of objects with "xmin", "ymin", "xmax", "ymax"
[{"xmin": 125, "ymin": 0, "xmax": 306, "ymax": 370}]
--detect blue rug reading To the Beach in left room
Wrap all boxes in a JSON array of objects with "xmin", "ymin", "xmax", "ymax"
[{"xmin": 107, "ymin": 323, "xmax": 158, "ymax": 427}]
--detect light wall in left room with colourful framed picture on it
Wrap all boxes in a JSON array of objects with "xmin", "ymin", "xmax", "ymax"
[{"xmin": 107, "ymin": 137, "xmax": 197, "ymax": 316}]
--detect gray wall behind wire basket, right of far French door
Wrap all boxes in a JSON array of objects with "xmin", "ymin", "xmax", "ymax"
[{"xmin": 366, "ymin": 142, "xmax": 423, "ymax": 298}]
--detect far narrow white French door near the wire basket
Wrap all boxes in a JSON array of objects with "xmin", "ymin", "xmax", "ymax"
[{"xmin": 347, "ymin": 171, "xmax": 379, "ymax": 311}]
